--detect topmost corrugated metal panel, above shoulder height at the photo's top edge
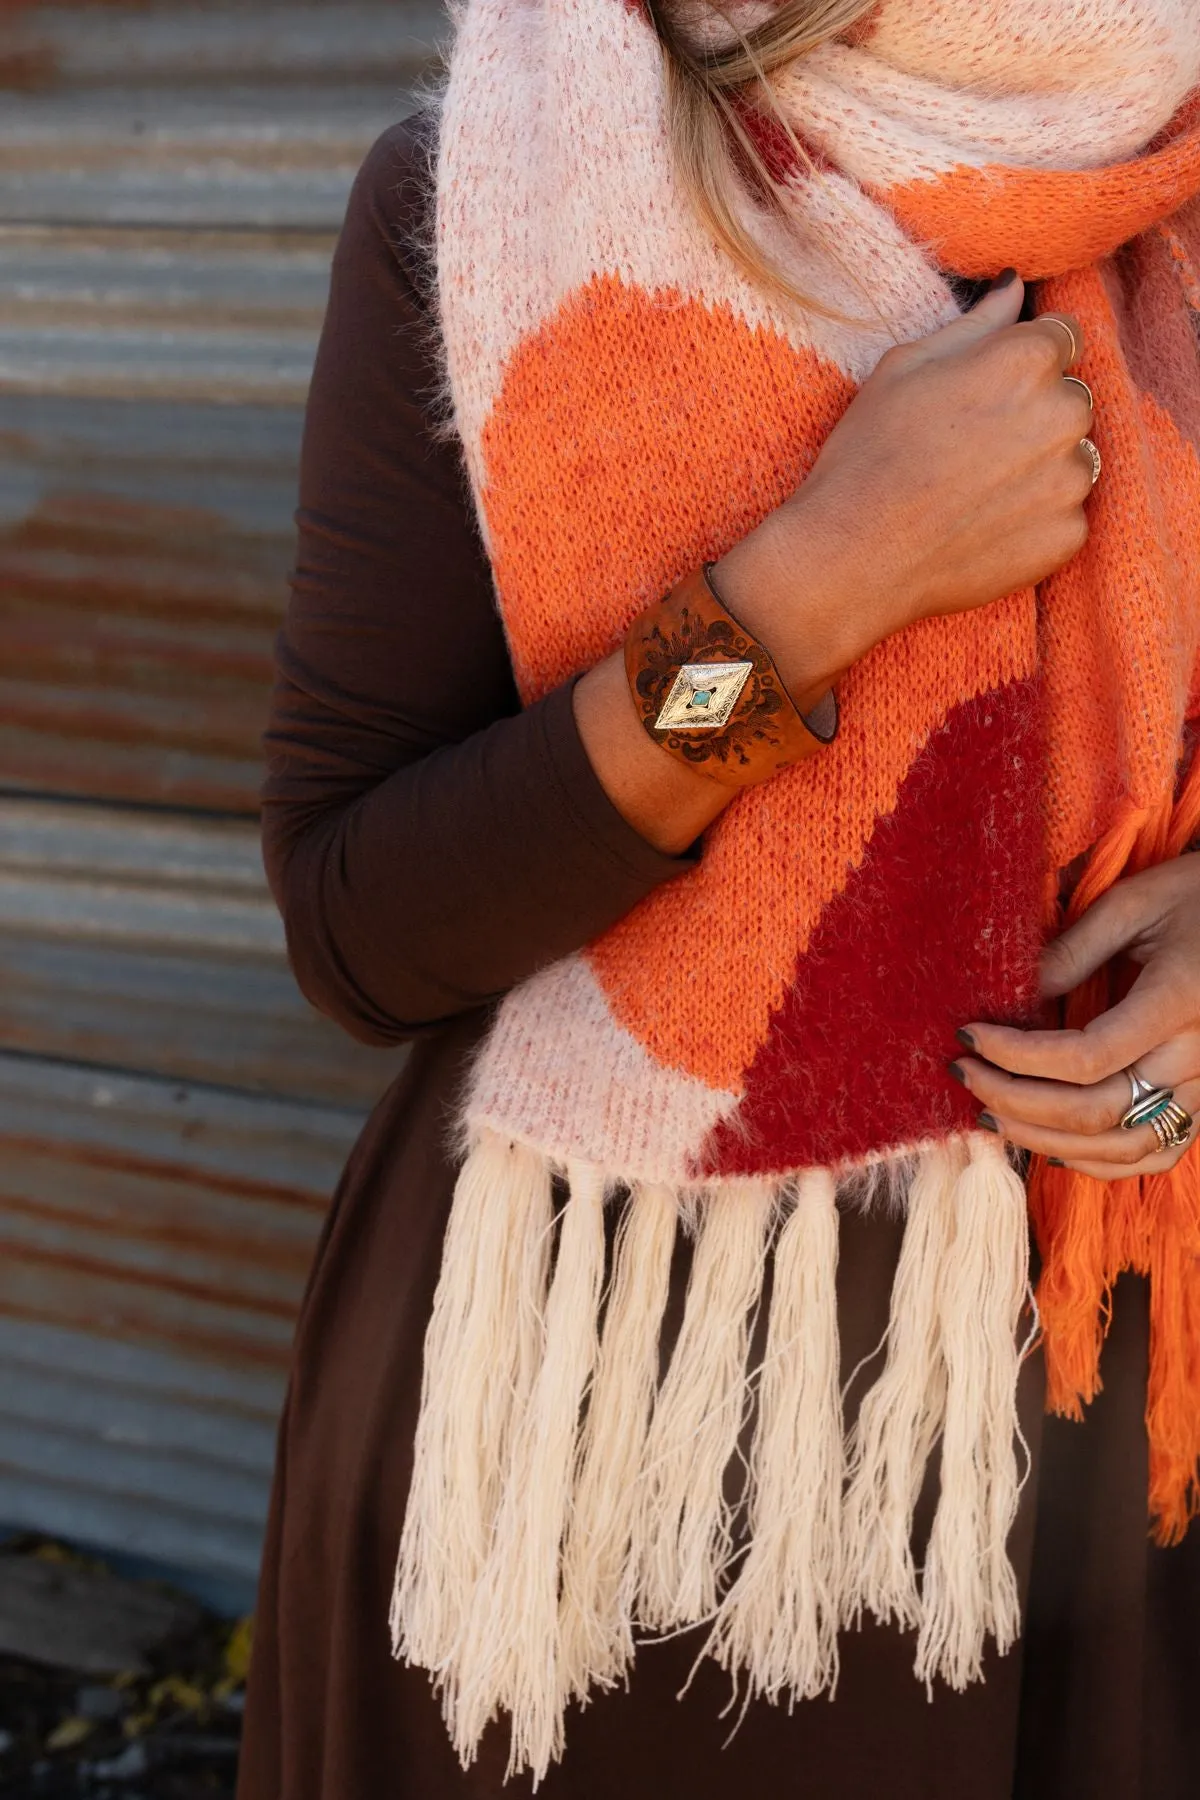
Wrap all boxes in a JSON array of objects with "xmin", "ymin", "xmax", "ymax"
[{"xmin": 0, "ymin": 4, "xmax": 444, "ymax": 229}]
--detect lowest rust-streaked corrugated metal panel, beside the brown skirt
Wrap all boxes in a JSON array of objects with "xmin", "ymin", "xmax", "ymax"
[{"xmin": 0, "ymin": 1055, "xmax": 360, "ymax": 1575}]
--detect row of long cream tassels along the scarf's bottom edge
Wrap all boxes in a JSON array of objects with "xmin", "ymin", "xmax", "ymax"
[{"xmin": 392, "ymin": 1130, "xmax": 1029, "ymax": 1782}]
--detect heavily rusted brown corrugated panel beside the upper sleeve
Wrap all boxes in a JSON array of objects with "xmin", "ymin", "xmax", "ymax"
[{"xmin": 0, "ymin": 394, "xmax": 300, "ymax": 812}]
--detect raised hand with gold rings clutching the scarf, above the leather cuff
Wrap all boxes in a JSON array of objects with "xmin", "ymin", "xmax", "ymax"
[{"xmin": 714, "ymin": 279, "xmax": 1092, "ymax": 707}]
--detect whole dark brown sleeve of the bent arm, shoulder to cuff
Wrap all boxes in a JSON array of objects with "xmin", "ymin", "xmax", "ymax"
[{"xmin": 263, "ymin": 122, "xmax": 689, "ymax": 1042}]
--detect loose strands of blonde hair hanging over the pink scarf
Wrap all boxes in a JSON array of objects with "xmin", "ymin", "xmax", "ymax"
[{"xmin": 644, "ymin": 0, "xmax": 878, "ymax": 311}]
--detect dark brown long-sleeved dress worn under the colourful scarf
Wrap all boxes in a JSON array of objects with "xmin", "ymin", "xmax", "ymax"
[{"xmin": 239, "ymin": 126, "xmax": 1200, "ymax": 1800}]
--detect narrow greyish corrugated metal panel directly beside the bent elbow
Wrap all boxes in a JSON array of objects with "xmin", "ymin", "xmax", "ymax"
[{"xmin": 0, "ymin": 797, "xmax": 403, "ymax": 1109}]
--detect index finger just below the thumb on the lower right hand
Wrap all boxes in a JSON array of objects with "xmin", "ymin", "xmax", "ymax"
[{"xmin": 961, "ymin": 963, "xmax": 1195, "ymax": 1087}]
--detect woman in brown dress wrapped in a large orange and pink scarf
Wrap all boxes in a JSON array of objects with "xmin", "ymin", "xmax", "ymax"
[{"xmin": 241, "ymin": 0, "xmax": 1200, "ymax": 1800}]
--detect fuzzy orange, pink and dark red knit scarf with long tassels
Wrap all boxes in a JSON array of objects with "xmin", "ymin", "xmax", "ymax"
[{"xmin": 392, "ymin": 0, "xmax": 1200, "ymax": 1778}]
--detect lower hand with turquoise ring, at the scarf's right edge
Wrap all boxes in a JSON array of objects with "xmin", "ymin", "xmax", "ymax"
[{"xmin": 950, "ymin": 855, "xmax": 1200, "ymax": 1181}]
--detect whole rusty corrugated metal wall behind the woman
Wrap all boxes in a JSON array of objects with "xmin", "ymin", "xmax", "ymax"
[{"xmin": 0, "ymin": 0, "xmax": 441, "ymax": 1589}]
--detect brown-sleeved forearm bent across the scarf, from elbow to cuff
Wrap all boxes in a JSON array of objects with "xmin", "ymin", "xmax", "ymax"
[{"xmin": 263, "ymin": 688, "xmax": 694, "ymax": 1042}]
